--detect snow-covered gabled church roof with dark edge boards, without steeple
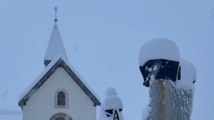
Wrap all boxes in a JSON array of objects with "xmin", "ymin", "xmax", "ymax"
[{"xmin": 18, "ymin": 56, "xmax": 101, "ymax": 107}]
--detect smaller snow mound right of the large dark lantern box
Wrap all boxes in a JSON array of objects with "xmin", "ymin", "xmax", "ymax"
[{"xmin": 176, "ymin": 59, "xmax": 196, "ymax": 89}]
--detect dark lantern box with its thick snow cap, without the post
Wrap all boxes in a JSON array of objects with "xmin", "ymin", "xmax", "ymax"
[{"xmin": 139, "ymin": 38, "xmax": 180, "ymax": 87}]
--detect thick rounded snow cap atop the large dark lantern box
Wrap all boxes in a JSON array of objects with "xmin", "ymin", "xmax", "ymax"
[{"xmin": 139, "ymin": 38, "xmax": 180, "ymax": 65}]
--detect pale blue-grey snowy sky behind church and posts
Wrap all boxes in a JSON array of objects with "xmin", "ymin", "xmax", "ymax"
[{"xmin": 0, "ymin": 0, "xmax": 214, "ymax": 120}]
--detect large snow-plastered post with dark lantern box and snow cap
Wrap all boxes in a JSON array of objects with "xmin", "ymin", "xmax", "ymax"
[{"xmin": 139, "ymin": 39, "xmax": 195, "ymax": 120}]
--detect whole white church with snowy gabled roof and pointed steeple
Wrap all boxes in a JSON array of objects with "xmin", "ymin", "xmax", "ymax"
[{"xmin": 18, "ymin": 7, "xmax": 101, "ymax": 120}]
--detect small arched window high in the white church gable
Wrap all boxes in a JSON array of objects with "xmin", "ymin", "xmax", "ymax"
[{"xmin": 55, "ymin": 89, "xmax": 68, "ymax": 107}]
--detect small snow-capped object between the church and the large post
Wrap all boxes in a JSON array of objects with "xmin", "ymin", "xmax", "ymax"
[{"xmin": 99, "ymin": 87, "xmax": 124, "ymax": 120}]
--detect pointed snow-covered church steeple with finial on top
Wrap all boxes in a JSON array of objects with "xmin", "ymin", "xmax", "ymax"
[{"xmin": 44, "ymin": 7, "xmax": 67, "ymax": 66}]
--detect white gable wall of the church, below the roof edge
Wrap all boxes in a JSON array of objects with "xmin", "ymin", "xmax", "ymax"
[{"xmin": 23, "ymin": 68, "xmax": 96, "ymax": 120}]
